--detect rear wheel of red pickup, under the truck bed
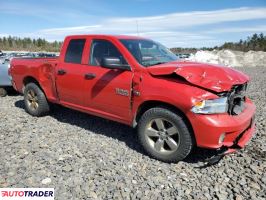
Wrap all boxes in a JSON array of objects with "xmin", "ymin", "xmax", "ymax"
[{"xmin": 24, "ymin": 83, "xmax": 50, "ymax": 117}]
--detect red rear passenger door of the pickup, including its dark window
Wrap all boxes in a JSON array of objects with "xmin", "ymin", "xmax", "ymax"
[{"xmin": 56, "ymin": 38, "xmax": 87, "ymax": 107}]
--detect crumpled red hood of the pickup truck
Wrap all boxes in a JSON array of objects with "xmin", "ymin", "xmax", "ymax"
[{"xmin": 147, "ymin": 61, "xmax": 249, "ymax": 92}]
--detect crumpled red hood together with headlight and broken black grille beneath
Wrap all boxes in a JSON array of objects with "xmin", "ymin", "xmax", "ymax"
[{"xmin": 147, "ymin": 62, "xmax": 249, "ymax": 115}]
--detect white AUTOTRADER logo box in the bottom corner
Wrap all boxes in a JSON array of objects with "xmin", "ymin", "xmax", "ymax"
[{"xmin": 0, "ymin": 188, "xmax": 54, "ymax": 200}]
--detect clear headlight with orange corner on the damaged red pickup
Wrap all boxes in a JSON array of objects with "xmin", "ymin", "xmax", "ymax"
[{"xmin": 191, "ymin": 97, "xmax": 228, "ymax": 114}]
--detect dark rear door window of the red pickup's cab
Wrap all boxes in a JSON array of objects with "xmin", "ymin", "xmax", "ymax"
[{"xmin": 65, "ymin": 39, "xmax": 86, "ymax": 64}]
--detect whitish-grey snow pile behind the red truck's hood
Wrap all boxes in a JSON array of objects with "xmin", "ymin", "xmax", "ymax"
[{"xmin": 188, "ymin": 50, "xmax": 266, "ymax": 67}]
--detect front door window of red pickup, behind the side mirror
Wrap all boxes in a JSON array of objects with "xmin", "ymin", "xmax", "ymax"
[{"xmin": 89, "ymin": 40, "xmax": 127, "ymax": 66}]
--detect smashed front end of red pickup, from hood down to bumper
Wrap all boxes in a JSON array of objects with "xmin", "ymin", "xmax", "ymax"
[{"xmin": 148, "ymin": 62, "xmax": 256, "ymax": 165}]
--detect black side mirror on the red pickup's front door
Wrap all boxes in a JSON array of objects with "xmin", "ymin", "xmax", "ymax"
[{"xmin": 101, "ymin": 57, "xmax": 131, "ymax": 71}]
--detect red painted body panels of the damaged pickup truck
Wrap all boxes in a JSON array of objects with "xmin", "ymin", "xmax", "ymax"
[{"xmin": 10, "ymin": 35, "xmax": 255, "ymax": 148}]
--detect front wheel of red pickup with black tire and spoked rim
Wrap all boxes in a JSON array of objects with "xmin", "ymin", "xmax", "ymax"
[{"xmin": 138, "ymin": 107, "xmax": 193, "ymax": 163}]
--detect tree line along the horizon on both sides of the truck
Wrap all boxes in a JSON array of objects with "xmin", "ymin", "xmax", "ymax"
[{"xmin": 0, "ymin": 33, "xmax": 266, "ymax": 53}]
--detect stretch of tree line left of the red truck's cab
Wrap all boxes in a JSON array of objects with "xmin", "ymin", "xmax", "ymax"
[{"xmin": 0, "ymin": 36, "xmax": 62, "ymax": 52}]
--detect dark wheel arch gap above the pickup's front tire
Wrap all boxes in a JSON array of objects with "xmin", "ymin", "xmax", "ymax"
[{"xmin": 133, "ymin": 100, "xmax": 196, "ymax": 144}]
